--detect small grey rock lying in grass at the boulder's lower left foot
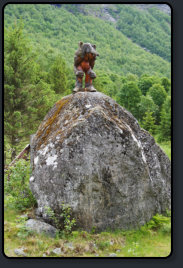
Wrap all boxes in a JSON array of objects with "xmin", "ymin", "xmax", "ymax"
[{"xmin": 25, "ymin": 219, "xmax": 57, "ymax": 237}]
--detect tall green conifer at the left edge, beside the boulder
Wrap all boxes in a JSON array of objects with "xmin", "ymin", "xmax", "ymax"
[{"xmin": 4, "ymin": 23, "xmax": 55, "ymax": 163}]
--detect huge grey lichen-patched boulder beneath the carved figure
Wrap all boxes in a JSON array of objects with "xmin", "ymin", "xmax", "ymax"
[{"xmin": 30, "ymin": 92, "xmax": 171, "ymax": 231}]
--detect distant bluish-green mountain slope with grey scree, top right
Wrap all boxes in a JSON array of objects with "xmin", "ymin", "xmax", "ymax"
[{"xmin": 62, "ymin": 4, "xmax": 171, "ymax": 61}]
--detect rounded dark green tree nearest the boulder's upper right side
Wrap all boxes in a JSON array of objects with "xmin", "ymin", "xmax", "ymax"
[{"xmin": 117, "ymin": 82, "xmax": 141, "ymax": 117}]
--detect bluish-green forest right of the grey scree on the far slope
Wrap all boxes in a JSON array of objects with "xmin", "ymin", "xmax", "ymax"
[{"xmin": 116, "ymin": 5, "xmax": 171, "ymax": 61}]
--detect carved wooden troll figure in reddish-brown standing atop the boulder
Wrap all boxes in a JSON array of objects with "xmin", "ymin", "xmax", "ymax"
[{"xmin": 73, "ymin": 42, "xmax": 99, "ymax": 93}]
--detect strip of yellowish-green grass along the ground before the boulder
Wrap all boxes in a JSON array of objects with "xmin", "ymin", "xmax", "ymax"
[{"xmin": 4, "ymin": 208, "xmax": 171, "ymax": 257}]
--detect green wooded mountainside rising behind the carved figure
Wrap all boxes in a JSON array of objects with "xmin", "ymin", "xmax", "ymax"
[{"xmin": 5, "ymin": 4, "xmax": 170, "ymax": 77}]
